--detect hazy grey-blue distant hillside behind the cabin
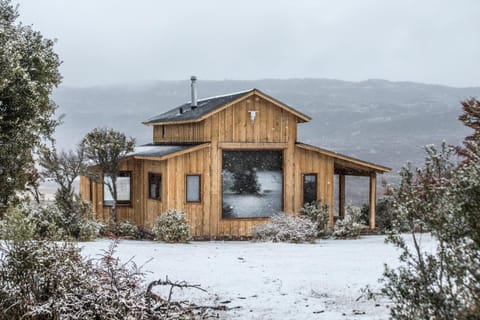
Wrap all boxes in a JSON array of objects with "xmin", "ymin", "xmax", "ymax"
[{"xmin": 53, "ymin": 79, "xmax": 480, "ymax": 188}]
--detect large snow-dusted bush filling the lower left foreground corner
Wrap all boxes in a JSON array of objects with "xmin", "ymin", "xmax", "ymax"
[{"xmin": 0, "ymin": 240, "xmax": 217, "ymax": 320}]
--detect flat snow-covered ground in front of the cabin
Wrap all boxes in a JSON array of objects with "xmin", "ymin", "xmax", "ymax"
[{"xmin": 80, "ymin": 236, "xmax": 433, "ymax": 320}]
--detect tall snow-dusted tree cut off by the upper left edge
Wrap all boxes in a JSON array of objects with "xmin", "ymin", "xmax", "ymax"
[{"xmin": 0, "ymin": 0, "xmax": 61, "ymax": 206}]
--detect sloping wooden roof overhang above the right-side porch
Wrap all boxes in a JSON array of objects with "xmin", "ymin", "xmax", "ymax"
[{"xmin": 296, "ymin": 143, "xmax": 392, "ymax": 176}]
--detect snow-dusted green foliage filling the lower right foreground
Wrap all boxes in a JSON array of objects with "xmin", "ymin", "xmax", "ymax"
[{"xmin": 383, "ymin": 144, "xmax": 480, "ymax": 320}]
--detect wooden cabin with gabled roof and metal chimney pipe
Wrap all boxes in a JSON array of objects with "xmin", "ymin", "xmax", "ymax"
[{"xmin": 80, "ymin": 80, "xmax": 390, "ymax": 239}]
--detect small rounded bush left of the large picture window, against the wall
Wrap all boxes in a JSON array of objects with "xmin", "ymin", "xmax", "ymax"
[{"xmin": 153, "ymin": 210, "xmax": 191, "ymax": 242}]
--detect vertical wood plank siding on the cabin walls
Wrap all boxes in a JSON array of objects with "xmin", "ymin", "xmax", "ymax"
[{"xmin": 80, "ymin": 95, "xmax": 366, "ymax": 238}]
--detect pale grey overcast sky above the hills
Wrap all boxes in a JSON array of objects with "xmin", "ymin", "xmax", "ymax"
[{"xmin": 14, "ymin": 0, "xmax": 480, "ymax": 87}]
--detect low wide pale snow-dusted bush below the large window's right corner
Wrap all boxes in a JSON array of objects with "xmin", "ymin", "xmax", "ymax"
[{"xmin": 252, "ymin": 213, "xmax": 317, "ymax": 243}]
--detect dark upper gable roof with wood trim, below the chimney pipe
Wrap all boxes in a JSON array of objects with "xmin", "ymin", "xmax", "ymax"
[{"xmin": 143, "ymin": 89, "xmax": 310, "ymax": 125}]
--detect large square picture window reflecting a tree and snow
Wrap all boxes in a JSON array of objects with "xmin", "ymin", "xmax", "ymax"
[{"xmin": 222, "ymin": 151, "xmax": 283, "ymax": 218}]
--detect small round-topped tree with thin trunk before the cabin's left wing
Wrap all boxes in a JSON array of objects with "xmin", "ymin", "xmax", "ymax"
[{"xmin": 81, "ymin": 128, "xmax": 135, "ymax": 224}]
